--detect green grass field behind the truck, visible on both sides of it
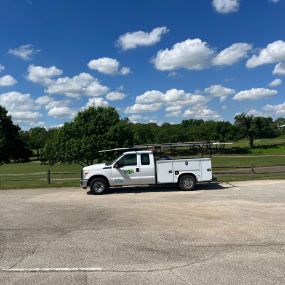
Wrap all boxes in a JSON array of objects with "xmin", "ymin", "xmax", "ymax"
[{"xmin": 0, "ymin": 135, "xmax": 285, "ymax": 189}]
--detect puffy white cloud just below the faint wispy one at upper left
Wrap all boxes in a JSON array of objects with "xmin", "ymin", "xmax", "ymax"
[{"xmin": 27, "ymin": 65, "xmax": 62, "ymax": 85}]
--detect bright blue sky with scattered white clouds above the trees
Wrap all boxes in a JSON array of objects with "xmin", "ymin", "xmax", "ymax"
[{"xmin": 0, "ymin": 0, "xmax": 285, "ymax": 129}]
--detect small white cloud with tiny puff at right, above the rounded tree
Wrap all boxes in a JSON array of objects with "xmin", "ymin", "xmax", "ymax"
[{"xmin": 87, "ymin": 57, "xmax": 131, "ymax": 75}]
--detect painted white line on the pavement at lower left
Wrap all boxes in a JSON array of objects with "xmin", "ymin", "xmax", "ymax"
[{"xmin": 0, "ymin": 267, "xmax": 102, "ymax": 272}]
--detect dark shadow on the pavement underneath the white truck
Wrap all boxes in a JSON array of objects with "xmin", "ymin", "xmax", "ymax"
[{"xmin": 87, "ymin": 182, "xmax": 231, "ymax": 195}]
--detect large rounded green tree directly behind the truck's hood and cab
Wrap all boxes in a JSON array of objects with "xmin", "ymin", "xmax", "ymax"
[{"xmin": 43, "ymin": 107, "xmax": 133, "ymax": 165}]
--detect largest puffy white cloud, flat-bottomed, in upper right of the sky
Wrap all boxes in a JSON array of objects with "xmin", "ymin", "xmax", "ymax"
[{"xmin": 153, "ymin": 39, "xmax": 214, "ymax": 70}]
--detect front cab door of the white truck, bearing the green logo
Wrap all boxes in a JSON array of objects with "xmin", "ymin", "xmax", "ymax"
[{"xmin": 111, "ymin": 153, "xmax": 140, "ymax": 186}]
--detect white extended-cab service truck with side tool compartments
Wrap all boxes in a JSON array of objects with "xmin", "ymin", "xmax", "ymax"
[{"xmin": 80, "ymin": 150, "xmax": 212, "ymax": 194}]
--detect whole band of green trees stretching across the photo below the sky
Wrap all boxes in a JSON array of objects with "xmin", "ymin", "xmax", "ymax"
[{"xmin": 0, "ymin": 106, "xmax": 285, "ymax": 165}]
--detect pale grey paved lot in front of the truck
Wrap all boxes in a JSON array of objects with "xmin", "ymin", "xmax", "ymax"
[{"xmin": 0, "ymin": 181, "xmax": 285, "ymax": 285}]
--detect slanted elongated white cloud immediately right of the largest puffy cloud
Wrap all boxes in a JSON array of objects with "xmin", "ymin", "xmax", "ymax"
[{"xmin": 212, "ymin": 43, "xmax": 252, "ymax": 65}]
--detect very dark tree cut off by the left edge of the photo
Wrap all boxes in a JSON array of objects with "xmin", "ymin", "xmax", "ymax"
[{"xmin": 0, "ymin": 106, "xmax": 31, "ymax": 163}]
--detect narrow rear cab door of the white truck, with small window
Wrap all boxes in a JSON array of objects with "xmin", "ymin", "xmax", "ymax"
[{"xmin": 139, "ymin": 153, "xmax": 155, "ymax": 184}]
